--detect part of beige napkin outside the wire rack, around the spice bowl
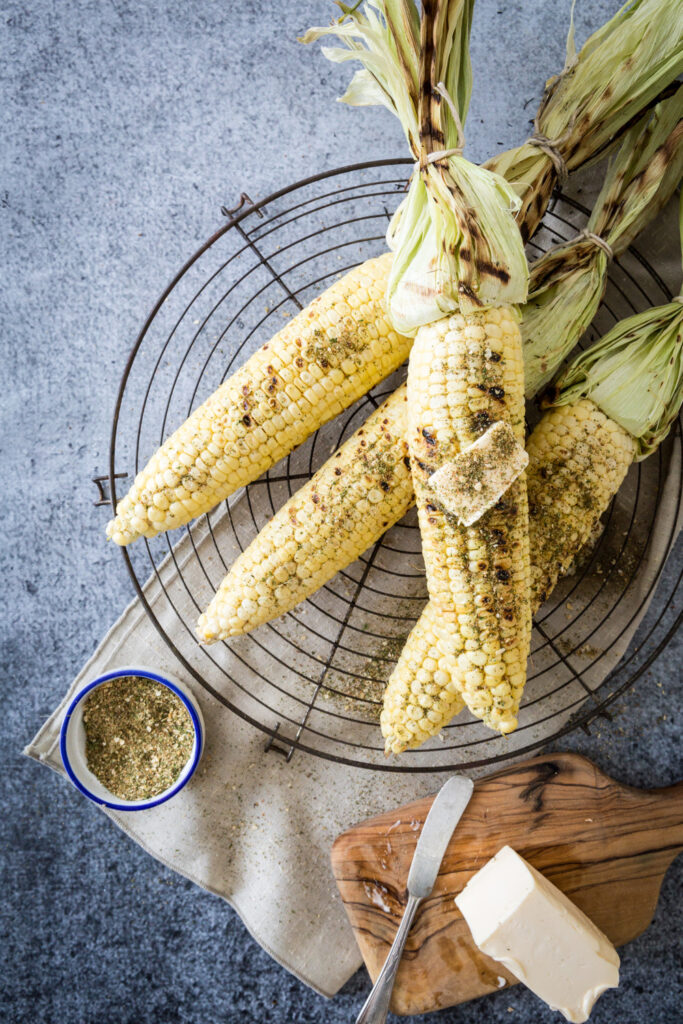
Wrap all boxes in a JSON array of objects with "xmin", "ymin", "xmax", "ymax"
[{"xmin": 25, "ymin": 541, "xmax": 454, "ymax": 996}]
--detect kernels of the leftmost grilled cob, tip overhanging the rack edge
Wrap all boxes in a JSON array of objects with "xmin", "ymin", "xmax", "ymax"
[{"xmin": 106, "ymin": 253, "xmax": 411, "ymax": 545}]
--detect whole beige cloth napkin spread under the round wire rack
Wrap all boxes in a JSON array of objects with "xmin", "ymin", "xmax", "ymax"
[{"xmin": 26, "ymin": 186, "xmax": 681, "ymax": 996}]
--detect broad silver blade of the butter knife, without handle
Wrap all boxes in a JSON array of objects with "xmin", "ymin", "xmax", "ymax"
[{"xmin": 408, "ymin": 775, "xmax": 474, "ymax": 899}]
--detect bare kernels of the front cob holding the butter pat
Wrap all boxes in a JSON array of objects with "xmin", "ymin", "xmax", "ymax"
[{"xmin": 408, "ymin": 307, "xmax": 531, "ymax": 732}]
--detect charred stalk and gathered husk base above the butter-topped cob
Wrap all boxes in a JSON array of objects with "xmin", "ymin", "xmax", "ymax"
[{"xmin": 387, "ymin": 0, "xmax": 528, "ymax": 332}]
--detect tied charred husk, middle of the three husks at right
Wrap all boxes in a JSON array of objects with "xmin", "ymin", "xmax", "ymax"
[{"xmin": 522, "ymin": 86, "xmax": 683, "ymax": 398}]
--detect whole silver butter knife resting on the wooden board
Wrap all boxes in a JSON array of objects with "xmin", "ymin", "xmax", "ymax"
[{"xmin": 355, "ymin": 775, "xmax": 474, "ymax": 1024}]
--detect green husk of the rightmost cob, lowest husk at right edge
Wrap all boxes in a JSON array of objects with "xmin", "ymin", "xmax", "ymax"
[{"xmin": 552, "ymin": 196, "xmax": 683, "ymax": 461}]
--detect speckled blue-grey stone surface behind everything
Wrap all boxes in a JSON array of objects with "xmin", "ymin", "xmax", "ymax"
[{"xmin": 0, "ymin": 0, "xmax": 683, "ymax": 1024}]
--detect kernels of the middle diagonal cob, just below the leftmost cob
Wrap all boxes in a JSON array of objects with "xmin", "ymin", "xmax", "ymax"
[{"xmin": 197, "ymin": 388, "xmax": 413, "ymax": 643}]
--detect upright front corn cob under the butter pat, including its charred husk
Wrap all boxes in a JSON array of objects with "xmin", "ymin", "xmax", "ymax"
[{"xmin": 387, "ymin": 0, "xmax": 531, "ymax": 733}]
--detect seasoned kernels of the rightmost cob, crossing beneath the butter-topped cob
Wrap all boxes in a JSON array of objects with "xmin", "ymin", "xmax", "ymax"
[{"xmin": 381, "ymin": 398, "xmax": 636, "ymax": 754}]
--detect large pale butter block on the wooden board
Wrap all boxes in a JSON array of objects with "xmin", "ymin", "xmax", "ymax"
[{"xmin": 456, "ymin": 846, "xmax": 620, "ymax": 1024}]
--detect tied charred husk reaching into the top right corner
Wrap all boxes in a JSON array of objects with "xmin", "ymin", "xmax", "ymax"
[{"xmin": 488, "ymin": 0, "xmax": 683, "ymax": 239}]
